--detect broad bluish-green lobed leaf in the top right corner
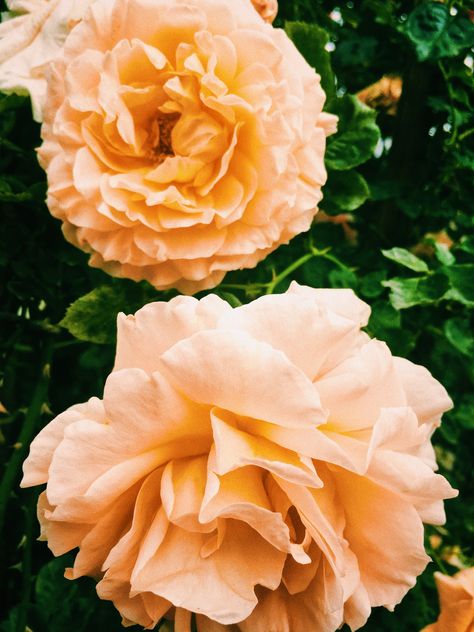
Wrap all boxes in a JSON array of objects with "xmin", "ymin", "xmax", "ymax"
[{"xmin": 404, "ymin": 2, "xmax": 474, "ymax": 61}]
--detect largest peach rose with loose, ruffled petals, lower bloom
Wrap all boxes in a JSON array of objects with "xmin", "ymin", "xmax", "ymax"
[{"xmin": 22, "ymin": 283, "xmax": 455, "ymax": 632}]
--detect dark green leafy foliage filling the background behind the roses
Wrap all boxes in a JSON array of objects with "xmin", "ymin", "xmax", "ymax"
[{"xmin": 0, "ymin": 0, "xmax": 474, "ymax": 632}]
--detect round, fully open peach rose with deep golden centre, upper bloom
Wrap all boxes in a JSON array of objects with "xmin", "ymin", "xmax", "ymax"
[{"xmin": 39, "ymin": 0, "xmax": 335, "ymax": 293}]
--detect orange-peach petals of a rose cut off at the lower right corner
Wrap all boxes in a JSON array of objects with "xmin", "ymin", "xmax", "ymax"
[{"xmin": 422, "ymin": 567, "xmax": 474, "ymax": 632}]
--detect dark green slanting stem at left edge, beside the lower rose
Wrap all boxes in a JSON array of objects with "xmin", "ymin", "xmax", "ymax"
[{"xmin": 0, "ymin": 340, "xmax": 53, "ymax": 534}]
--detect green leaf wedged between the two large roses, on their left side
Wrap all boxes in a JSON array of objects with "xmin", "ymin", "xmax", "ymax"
[{"xmin": 59, "ymin": 281, "xmax": 157, "ymax": 344}]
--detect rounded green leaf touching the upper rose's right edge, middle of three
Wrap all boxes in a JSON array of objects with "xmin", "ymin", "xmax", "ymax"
[{"xmin": 325, "ymin": 95, "xmax": 380, "ymax": 171}]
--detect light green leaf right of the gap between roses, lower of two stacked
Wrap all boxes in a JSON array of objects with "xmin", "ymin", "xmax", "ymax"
[{"xmin": 382, "ymin": 273, "xmax": 449, "ymax": 309}]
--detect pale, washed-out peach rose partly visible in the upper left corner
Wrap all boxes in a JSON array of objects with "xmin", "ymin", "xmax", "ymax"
[{"xmin": 0, "ymin": 0, "xmax": 91, "ymax": 121}]
